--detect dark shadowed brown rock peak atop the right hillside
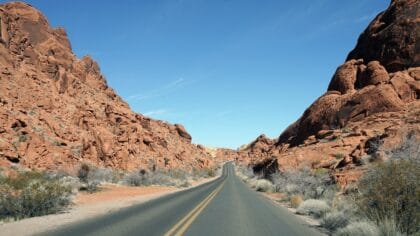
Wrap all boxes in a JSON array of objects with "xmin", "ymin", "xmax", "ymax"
[{"xmin": 347, "ymin": 0, "xmax": 420, "ymax": 72}]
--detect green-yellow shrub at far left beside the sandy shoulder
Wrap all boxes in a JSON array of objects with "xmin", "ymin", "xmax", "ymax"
[{"xmin": 0, "ymin": 172, "xmax": 72, "ymax": 219}]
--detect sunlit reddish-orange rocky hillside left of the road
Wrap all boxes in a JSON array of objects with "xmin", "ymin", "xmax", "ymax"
[{"xmin": 0, "ymin": 2, "xmax": 212, "ymax": 169}]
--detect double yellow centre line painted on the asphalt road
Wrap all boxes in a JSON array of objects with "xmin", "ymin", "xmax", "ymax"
[{"xmin": 164, "ymin": 180, "xmax": 226, "ymax": 236}]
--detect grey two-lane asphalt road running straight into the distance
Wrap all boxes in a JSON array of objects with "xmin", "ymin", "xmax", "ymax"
[{"xmin": 43, "ymin": 163, "xmax": 321, "ymax": 236}]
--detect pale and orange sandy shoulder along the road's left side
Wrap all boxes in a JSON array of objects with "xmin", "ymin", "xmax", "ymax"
[{"xmin": 0, "ymin": 177, "xmax": 217, "ymax": 236}]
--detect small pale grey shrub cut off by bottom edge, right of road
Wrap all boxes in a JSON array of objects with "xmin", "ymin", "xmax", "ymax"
[{"xmin": 335, "ymin": 221, "xmax": 380, "ymax": 236}]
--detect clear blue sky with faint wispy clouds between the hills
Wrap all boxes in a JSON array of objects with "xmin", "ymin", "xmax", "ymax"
[{"xmin": 4, "ymin": 0, "xmax": 389, "ymax": 148}]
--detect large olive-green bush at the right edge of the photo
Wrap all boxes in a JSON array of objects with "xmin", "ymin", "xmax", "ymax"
[{"xmin": 357, "ymin": 159, "xmax": 420, "ymax": 234}]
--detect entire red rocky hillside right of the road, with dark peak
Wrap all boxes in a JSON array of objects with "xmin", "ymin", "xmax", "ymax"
[{"xmin": 237, "ymin": 0, "xmax": 420, "ymax": 184}]
